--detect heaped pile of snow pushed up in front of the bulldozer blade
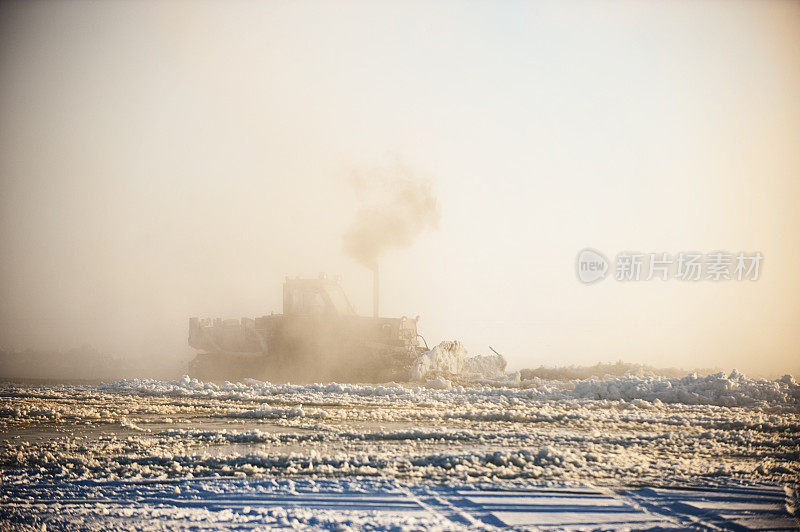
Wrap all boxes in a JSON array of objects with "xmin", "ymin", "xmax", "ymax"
[{"xmin": 411, "ymin": 341, "xmax": 506, "ymax": 381}]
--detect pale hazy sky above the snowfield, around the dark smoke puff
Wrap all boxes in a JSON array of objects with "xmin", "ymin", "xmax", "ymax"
[{"xmin": 0, "ymin": 0, "xmax": 800, "ymax": 375}]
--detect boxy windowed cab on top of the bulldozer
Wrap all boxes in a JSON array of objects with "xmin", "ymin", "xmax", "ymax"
[{"xmin": 283, "ymin": 276, "xmax": 356, "ymax": 317}]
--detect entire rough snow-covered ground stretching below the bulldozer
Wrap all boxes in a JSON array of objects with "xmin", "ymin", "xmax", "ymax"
[{"xmin": 0, "ymin": 372, "xmax": 800, "ymax": 529}]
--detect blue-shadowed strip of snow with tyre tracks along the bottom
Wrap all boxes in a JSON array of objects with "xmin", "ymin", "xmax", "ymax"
[{"xmin": 0, "ymin": 479, "xmax": 798, "ymax": 530}]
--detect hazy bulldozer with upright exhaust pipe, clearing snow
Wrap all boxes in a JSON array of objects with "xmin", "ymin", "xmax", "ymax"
[{"xmin": 189, "ymin": 271, "xmax": 427, "ymax": 383}]
